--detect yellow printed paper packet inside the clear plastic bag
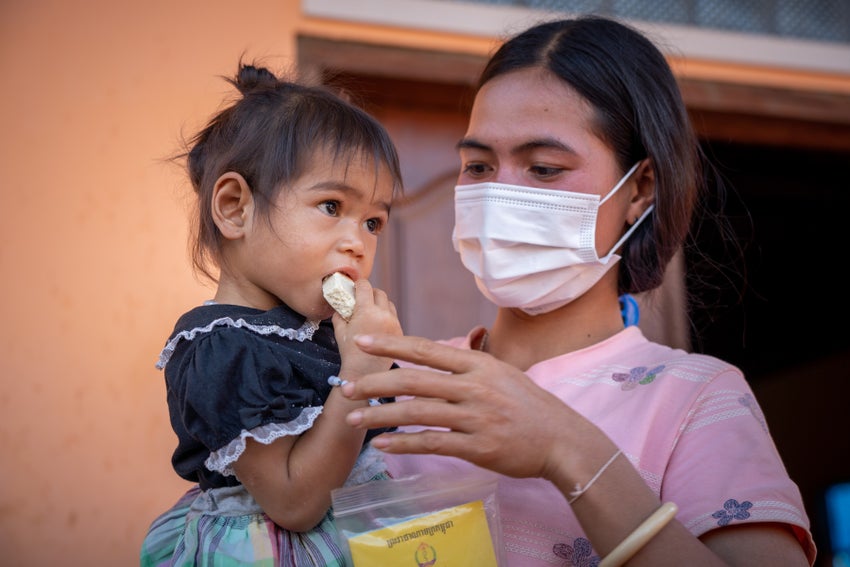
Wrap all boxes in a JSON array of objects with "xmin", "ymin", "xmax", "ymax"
[{"xmin": 348, "ymin": 500, "xmax": 498, "ymax": 567}]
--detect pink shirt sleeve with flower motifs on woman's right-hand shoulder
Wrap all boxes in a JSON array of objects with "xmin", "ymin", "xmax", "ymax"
[{"xmin": 661, "ymin": 368, "xmax": 814, "ymax": 562}]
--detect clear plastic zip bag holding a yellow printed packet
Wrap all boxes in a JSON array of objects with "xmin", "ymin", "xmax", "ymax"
[{"xmin": 331, "ymin": 471, "xmax": 505, "ymax": 567}]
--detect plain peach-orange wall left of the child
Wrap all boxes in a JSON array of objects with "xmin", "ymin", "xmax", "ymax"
[{"xmin": 0, "ymin": 0, "xmax": 301, "ymax": 567}]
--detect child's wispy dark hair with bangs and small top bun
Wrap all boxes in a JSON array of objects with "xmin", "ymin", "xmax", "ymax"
[{"xmin": 181, "ymin": 62, "xmax": 402, "ymax": 281}]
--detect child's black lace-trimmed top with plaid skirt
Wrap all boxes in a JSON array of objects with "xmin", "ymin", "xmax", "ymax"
[{"xmin": 141, "ymin": 302, "xmax": 391, "ymax": 565}]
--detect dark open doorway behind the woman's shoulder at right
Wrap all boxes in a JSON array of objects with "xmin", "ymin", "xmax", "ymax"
[{"xmin": 687, "ymin": 141, "xmax": 850, "ymax": 567}]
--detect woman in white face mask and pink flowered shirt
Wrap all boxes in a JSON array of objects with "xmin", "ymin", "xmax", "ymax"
[{"xmin": 334, "ymin": 17, "xmax": 815, "ymax": 567}]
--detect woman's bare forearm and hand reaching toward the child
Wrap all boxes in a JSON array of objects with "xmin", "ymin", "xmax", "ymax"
[{"xmin": 342, "ymin": 335, "xmax": 808, "ymax": 566}]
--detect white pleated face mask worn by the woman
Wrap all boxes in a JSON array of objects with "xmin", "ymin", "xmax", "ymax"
[{"xmin": 452, "ymin": 162, "xmax": 654, "ymax": 315}]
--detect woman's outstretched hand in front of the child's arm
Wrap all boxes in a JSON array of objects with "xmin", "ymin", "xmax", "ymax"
[{"xmin": 342, "ymin": 335, "xmax": 593, "ymax": 480}]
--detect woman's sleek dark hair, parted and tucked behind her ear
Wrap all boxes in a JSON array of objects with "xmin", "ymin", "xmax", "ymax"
[{"xmin": 478, "ymin": 16, "xmax": 704, "ymax": 294}]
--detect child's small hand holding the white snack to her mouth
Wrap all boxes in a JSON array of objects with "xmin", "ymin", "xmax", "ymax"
[{"xmin": 333, "ymin": 279, "xmax": 402, "ymax": 380}]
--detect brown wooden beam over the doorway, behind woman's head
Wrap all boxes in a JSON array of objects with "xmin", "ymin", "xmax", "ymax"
[{"xmin": 296, "ymin": 34, "xmax": 850, "ymax": 151}]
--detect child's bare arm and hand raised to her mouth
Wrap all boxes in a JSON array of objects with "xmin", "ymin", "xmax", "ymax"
[{"xmin": 233, "ymin": 280, "xmax": 401, "ymax": 531}]
